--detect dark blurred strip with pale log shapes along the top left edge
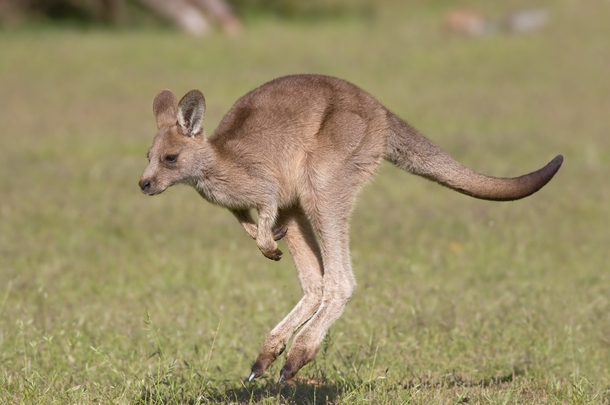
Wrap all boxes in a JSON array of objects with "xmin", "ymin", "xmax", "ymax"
[{"xmin": 0, "ymin": 0, "xmax": 376, "ymax": 35}]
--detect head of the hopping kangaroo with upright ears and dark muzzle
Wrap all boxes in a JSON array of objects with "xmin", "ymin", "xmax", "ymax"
[{"xmin": 139, "ymin": 90, "xmax": 206, "ymax": 195}]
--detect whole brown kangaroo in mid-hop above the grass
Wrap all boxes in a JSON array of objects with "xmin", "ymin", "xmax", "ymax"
[{"xmin": 139, "ymin": 75, "xmax": 563, "ymax": 382}]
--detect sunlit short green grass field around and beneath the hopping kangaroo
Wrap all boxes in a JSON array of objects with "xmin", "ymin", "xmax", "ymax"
[{"xmin": 0, "ymin": 0, "xmax": 610, "ymax": 405}]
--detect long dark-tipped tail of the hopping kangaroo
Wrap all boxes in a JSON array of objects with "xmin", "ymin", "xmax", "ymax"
[{"xmin": 384, "ymin": 112, "xmax": 563, "ymax": 201}]
